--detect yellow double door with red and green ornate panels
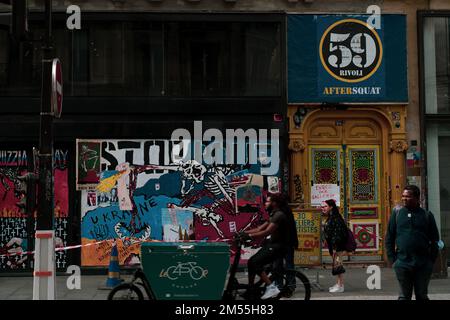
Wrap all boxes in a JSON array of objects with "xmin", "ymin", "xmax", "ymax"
[{"xmin": 308, "ymin": 144, "xmax": 383, "ymax": 260}]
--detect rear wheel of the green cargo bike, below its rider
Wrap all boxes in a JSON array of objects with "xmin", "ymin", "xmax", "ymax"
[{"xmin": 277, "ymin": 270, "xmax": 311, "ymax": 300}]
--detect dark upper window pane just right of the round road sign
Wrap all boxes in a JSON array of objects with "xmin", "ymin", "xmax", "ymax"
[{"xmin": 73, "ymin": 22, "xmax": 163, "ymax": 96}]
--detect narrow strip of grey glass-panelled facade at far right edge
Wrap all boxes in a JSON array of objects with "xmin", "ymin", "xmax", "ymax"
[{"xmin": 418, "ymin": 7, "xmax": 450, "ymax": 266}]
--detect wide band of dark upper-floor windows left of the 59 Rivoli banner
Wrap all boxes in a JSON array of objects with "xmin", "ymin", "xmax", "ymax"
[{"xmin": 0, "ymin": 20, "xmax": 281, "ymax": 97}]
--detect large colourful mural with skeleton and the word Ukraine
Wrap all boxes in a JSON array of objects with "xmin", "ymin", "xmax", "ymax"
[{"xmin": 77, "ymin": 140, "xmax": 281, "ymax": 266}]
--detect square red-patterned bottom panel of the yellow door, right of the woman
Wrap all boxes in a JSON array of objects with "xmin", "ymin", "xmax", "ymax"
[{"xmin": 351, "ymin": 221, "xmax": 379, "ymax": 251}]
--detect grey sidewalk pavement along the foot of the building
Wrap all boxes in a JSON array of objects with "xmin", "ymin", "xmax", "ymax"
[{"xmin": 0, "ymin": 267, "xmax": 450, "ymax": 300}]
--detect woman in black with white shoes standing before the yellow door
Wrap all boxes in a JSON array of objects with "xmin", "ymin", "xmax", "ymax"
[{"xmin": 321, "ymin": 199, "xmax": 348, "ymax": 293}]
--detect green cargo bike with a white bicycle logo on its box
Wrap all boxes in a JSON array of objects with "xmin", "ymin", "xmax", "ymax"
[{"xmin": 108, "ymin": 235, "xmax": 311, "ymax": 300}]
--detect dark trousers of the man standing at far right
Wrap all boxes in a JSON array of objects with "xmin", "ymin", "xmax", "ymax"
[{"xmin": 394, "ymin": 261, "xmax": 433, "ymax": 300}]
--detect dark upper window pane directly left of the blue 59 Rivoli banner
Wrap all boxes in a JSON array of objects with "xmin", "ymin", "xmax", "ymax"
[{"xmin": 166, "ymin": 22, "xmax": 281, "ymax": 96}]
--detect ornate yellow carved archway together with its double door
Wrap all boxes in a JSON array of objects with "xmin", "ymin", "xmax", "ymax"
[{"xmin": 289, "ymin": 107, "xmax": 407, "ymax": 260}]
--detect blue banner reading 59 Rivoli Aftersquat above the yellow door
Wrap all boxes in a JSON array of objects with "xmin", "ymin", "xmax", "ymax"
[{"xmin": 287, "ymin": 14, "xmax": 408, "ymax": 103}]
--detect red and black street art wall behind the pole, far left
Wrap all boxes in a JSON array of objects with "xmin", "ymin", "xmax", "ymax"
[{"xmin": 0, "ymin": 149, "xmax": 69, "ymax": 271}]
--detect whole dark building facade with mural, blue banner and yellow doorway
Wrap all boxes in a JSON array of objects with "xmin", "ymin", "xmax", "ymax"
[{"xmin": 0, "ymin": 0, "xmax": 450, "ymax": 272}]
